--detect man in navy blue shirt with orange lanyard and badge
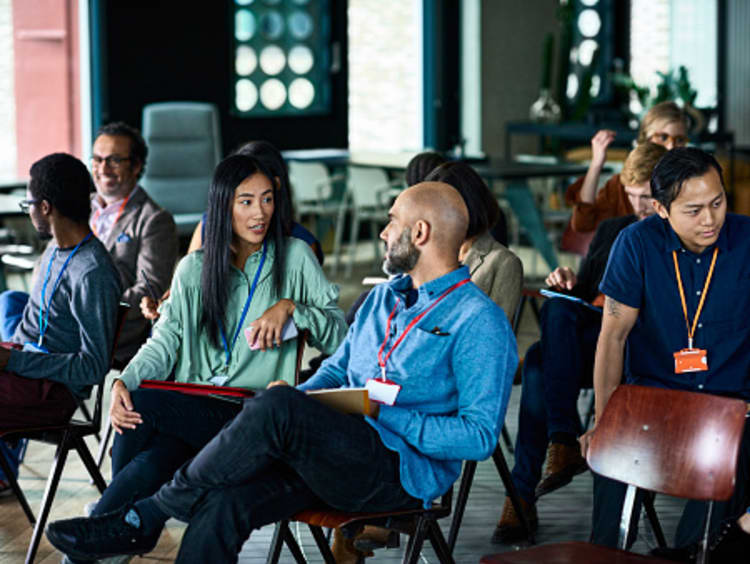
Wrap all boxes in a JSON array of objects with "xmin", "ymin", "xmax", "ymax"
[{"xmin": 581, "ymin": 148, "xmax": 750, "ymax": 546}]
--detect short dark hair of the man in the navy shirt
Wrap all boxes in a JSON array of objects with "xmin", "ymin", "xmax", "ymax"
[{"xmin": 651, "ymin": 147, "xmax": 724, "ymax": 211}]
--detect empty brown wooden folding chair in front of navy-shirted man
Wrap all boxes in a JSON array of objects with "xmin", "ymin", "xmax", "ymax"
[{"xmin": 480, "ymin": 385, "xmax": 747, "ymax": 564}]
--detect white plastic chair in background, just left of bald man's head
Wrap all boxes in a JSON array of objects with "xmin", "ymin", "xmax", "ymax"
[{"xmin": 345, "ymin": 166, "xmax": 403, "ymax": 278}]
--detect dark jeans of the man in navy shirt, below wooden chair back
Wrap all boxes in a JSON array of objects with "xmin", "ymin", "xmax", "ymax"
[{"xmin": 591, "ymin": 414, "xmax": 750, "ymax": 547}]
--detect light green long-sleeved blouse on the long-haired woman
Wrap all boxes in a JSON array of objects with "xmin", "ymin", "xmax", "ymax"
[{"xmin": 120, "ymin": 238, "xmax": 347, "ymax": 390}]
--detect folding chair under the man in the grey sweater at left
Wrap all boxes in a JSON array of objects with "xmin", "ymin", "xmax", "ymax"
[{"xmin": 0, "ymin": 303, "xmax": 129, "ymax": 564}]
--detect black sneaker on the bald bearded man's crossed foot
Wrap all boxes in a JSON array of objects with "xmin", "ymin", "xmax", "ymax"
[{"xmin": 46, "ymin": 505, "xmax": 161, "ymax": 560}]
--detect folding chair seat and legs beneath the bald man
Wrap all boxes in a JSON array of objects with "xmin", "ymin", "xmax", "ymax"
[{"xmin": 266, "ymin": 487, "xmax": 456, "ymax": 564}]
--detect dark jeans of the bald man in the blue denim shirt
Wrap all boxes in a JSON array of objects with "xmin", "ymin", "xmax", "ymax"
[{"xmin": 152, "ymin": 386, "xmax": 422, "ymax": 563}]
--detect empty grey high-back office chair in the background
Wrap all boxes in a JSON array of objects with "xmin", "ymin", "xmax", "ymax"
[{"xmin": 140, "ymin": 102, "xmax": 221, "ymax": 236}]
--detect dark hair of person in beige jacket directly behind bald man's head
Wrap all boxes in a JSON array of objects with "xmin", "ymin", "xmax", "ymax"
[{"xmin": 425, "ymin": 161, "xmax": 501, "ymax": 239}]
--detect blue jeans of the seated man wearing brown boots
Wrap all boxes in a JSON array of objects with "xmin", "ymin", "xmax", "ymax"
[{"xmin": 511, "ymin": 298, "xmax": 601, "ymax": 503}]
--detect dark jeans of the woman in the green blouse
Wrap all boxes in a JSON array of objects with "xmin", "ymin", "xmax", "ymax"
[{"xmin": 92, "ymin": 390, "xmax": 241, "ymax": 515}]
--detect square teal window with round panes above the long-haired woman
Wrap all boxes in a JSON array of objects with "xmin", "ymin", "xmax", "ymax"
[{"xmin": 232, "ymin": 0, "xmax": 331, "ymax": 117}]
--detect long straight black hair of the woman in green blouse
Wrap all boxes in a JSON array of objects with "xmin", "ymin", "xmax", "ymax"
[{"xmin": 201, "ymin": 155, "xmax": 291, "ymax": 347}]
